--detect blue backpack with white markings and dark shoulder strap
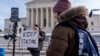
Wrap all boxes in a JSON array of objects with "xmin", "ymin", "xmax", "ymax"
[{"xmin": 57, "ymin": 21, "xmax": 100, "ymax": 56}]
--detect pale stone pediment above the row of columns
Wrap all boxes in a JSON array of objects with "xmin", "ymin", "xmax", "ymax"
[{"xmin": 26, "ymin": 0, "xmax": 58, "ymax": 8}]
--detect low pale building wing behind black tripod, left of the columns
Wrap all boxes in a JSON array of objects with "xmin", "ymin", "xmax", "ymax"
[{"xmin": 4, "ymin": 17, "xmax": 26, "ymax": 34}]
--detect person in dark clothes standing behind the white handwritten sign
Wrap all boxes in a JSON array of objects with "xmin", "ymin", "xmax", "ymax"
[{"xmin": 28, "ymin": 25, "xmax": 45, "ymax": 56}]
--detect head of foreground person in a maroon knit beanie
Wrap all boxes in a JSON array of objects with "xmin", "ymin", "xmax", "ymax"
[{"xmin": 53, "ymin": 0, "xmax": 71, "ymax": 21}]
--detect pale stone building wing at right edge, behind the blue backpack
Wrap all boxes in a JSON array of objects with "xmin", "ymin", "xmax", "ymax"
[{"xmin": 87, "ymin": 14, "xmax": 100, "ymax": 32}]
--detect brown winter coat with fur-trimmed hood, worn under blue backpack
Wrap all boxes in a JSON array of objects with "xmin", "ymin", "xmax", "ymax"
[{"xmin": 46, "ymin": 6, "xmax": 88, "ymax": 56}]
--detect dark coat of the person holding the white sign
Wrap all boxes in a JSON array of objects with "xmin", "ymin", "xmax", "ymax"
[{"xmin": 28, "ymin": 31, "xmax": 45, "ymax": 51}]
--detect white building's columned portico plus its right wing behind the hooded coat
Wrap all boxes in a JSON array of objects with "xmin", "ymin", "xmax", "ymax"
[{"xmin": 26, "ymin": 0, "xmax": 100, "ymax": 33}]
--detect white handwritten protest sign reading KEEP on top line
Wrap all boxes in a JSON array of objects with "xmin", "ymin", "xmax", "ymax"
[{"xmin": 20, "ymin": 30, "xmax": 39, "ymax": 48}]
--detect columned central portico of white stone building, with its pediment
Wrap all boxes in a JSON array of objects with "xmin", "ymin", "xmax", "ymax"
[{"xmin": 26, "ymin": 0, "xmax": 58, "ymax": 32}]
